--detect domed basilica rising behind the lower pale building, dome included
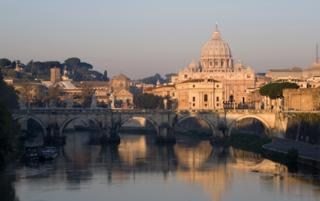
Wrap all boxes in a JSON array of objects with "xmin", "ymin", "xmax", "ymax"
[{"xmin": 172, "ymin": 27, "xmax": 256, "ymax": 103}]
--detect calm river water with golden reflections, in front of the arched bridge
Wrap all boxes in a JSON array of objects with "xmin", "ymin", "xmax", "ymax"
[{"xmin": 0, "ymin": 133, "xmax": 320, "ymax": 201}]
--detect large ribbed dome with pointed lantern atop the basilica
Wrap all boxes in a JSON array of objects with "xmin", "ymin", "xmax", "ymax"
[{"xmin": 200, "ymin": 28, "xmax": 233, "ymax": 72}]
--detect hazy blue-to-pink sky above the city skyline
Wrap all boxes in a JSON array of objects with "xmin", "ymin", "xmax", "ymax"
[{"xmin": 0, "ymin": 0, "xmax": 320, "ymax": 78}]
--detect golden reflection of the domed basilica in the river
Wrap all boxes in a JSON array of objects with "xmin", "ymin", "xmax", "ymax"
[{"xmin": 175, "ymin": 141, "xmax": 232, "ymax": 201}]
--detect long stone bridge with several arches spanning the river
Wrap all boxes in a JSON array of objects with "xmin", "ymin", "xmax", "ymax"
[{"xmin": 13, "ymin": 108, "xmax": 287, "ymax": 143}]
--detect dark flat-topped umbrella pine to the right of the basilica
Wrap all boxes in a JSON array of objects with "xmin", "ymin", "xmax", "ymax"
[{"xmin": 259, "ymin": 82, "xmax": 299, "ymax": 99}]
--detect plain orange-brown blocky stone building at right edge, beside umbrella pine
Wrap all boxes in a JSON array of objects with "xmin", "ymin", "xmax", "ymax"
[{"xmin": 283, "ymin": 88, "xmax": 320, "ymax": 111}]
